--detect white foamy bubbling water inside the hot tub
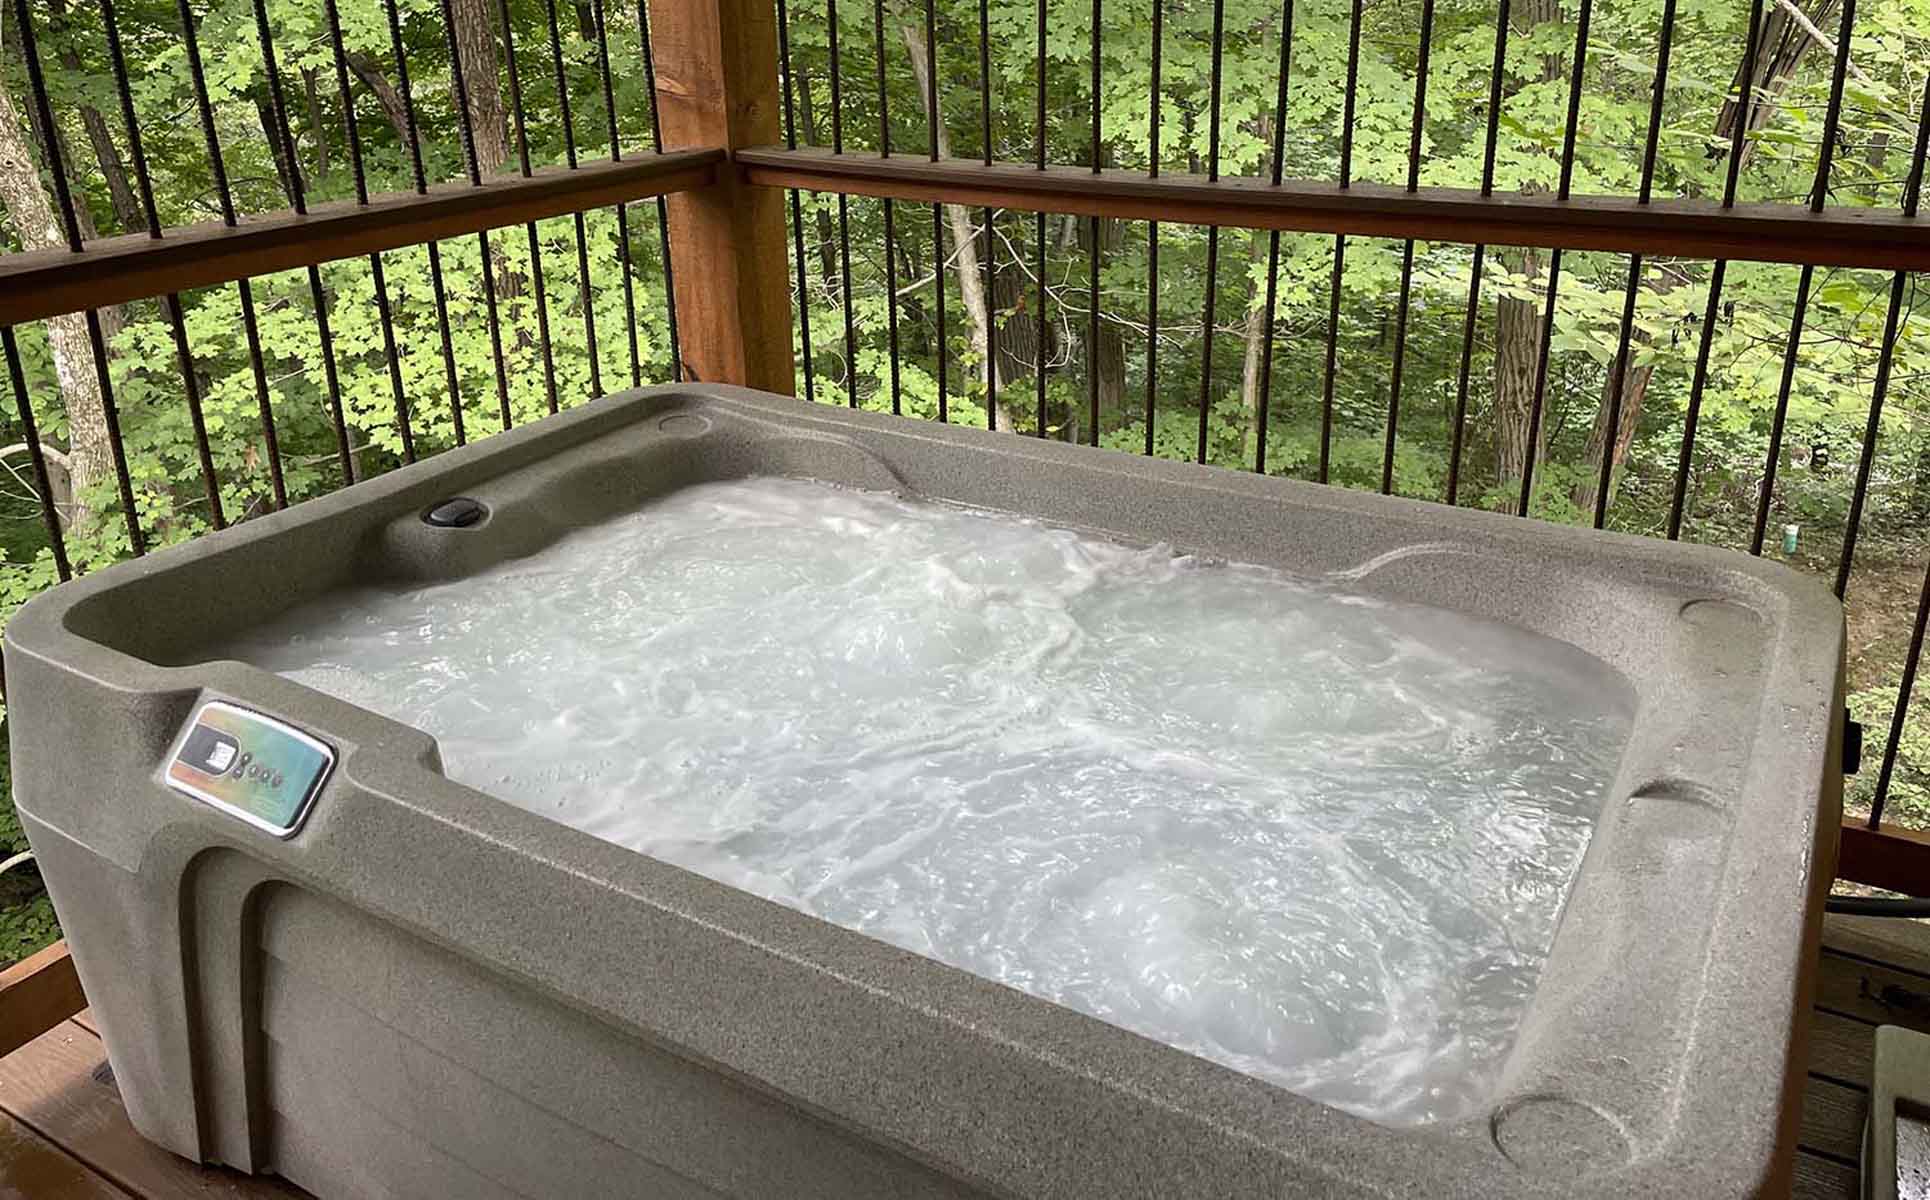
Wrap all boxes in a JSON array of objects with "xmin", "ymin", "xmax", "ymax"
[{"xmin": 230, "ymin": 478, "xmax": 1629, "ymax": 1123}]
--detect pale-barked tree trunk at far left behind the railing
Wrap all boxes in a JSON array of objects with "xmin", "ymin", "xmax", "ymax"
[{"xmin": 0, "ymin": 75, "xmax": 114, "ymax": 527}]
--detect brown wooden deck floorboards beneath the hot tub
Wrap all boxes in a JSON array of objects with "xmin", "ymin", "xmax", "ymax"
[{"xmin": 0, "ymin": 916, "xmax": 1930, "ymax": 1200}]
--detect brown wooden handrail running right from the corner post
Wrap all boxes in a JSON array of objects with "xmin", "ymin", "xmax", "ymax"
[{"xmin": 731, "ymin": 147, "xmax": 1930, "ymax": 270}]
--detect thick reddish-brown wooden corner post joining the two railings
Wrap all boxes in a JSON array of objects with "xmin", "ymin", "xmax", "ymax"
[{"xmin": 650, "ymin": 0, "xmax": 795, "ymax": 395}]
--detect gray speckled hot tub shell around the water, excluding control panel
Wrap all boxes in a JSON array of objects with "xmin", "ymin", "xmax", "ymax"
[{"xmin": 6, "ymin": 386, "xmax": 1843, "ymax": 1200}]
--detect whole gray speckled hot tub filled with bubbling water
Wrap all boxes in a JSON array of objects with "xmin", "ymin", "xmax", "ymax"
[{"xmin": 6, "ymin": 386, "xmax": 1843, "ymax": 1200}]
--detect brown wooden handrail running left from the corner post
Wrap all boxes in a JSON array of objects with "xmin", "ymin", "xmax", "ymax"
[{"xmin": 0, "ymin": 149, "xmax": 724, "ymax": 324}]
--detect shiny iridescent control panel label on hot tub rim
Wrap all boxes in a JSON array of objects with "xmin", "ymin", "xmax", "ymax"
[{"xmin": 166, "ymin": 700, "xmax": 336, "ymax": 837}]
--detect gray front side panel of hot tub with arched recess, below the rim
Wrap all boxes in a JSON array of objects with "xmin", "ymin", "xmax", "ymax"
[{"xmin": 15, "ymin": 822, "xmax": 984, "ymax": 1200}]
